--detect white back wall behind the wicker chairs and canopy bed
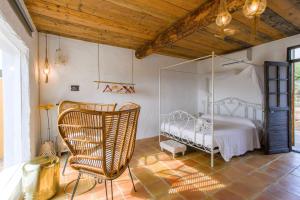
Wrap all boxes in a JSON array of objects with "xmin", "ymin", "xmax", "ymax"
[{"xmin": 39, "ymin": 34, "xmax": 300, "ymax": 139}]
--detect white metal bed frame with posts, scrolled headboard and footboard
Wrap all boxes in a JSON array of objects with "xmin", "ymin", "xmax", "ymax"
[{"xmin": 159, "ymin": 52, "xmax": 263, "ymax": 167}]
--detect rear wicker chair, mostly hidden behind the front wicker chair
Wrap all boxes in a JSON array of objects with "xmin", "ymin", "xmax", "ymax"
[{"xmin": 58, "ymin": 101, "xmax": 117, "ymax": 176}]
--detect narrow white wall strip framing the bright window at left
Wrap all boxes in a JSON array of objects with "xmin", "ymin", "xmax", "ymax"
[{"xmin": 0, "ymin": 0, "xmax": 40, "ymax": 156}]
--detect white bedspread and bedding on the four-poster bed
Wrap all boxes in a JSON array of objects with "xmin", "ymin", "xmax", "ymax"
[{"xmin": 161, "ymin": 115, "xmax": 260, "ymax": 161}]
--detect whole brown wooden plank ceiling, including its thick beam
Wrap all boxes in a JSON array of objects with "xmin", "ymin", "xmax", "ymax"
[{"xmin": 25, "ymin": 0, "xmax": 300, "ymax": 58}]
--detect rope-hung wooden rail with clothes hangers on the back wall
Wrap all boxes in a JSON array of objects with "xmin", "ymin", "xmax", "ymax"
[{"xmin": 94, "ymin": 40, "xmax": 135, "ymax": 94}]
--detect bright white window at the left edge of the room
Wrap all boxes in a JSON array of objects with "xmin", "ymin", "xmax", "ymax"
[{"xmin": 0, "ymin": 10, "xmax": 30, "ymax": 167}]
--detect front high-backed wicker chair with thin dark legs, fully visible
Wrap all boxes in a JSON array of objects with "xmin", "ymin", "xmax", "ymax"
[{"xmin": 58, "ymin": 103, "xmax": 140, "ymax": 199}]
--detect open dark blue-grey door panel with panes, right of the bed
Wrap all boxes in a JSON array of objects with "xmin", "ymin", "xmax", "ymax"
[{"xmin": 265, "ymin": 61, "xmax": 291, "ymax": 154}]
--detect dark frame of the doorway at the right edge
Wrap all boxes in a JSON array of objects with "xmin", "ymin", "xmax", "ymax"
[{"xmin": 287, "ymin": 44, "xmax": 300, "ymax": 151}]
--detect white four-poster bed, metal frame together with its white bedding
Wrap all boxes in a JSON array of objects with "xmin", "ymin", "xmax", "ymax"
[{"xmin": 159, "ymin": 53, "xmax": 263, "ymax": 167}]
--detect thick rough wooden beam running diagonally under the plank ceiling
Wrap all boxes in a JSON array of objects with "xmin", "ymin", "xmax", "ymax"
[{"xmin": 135, "ymin": 0, "xmax": 245, "ymax": 58}]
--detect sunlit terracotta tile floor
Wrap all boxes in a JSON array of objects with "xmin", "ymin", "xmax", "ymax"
[{"xmin": 54, "ymin": 138, "xmax": 300, "ymax": 200}]
